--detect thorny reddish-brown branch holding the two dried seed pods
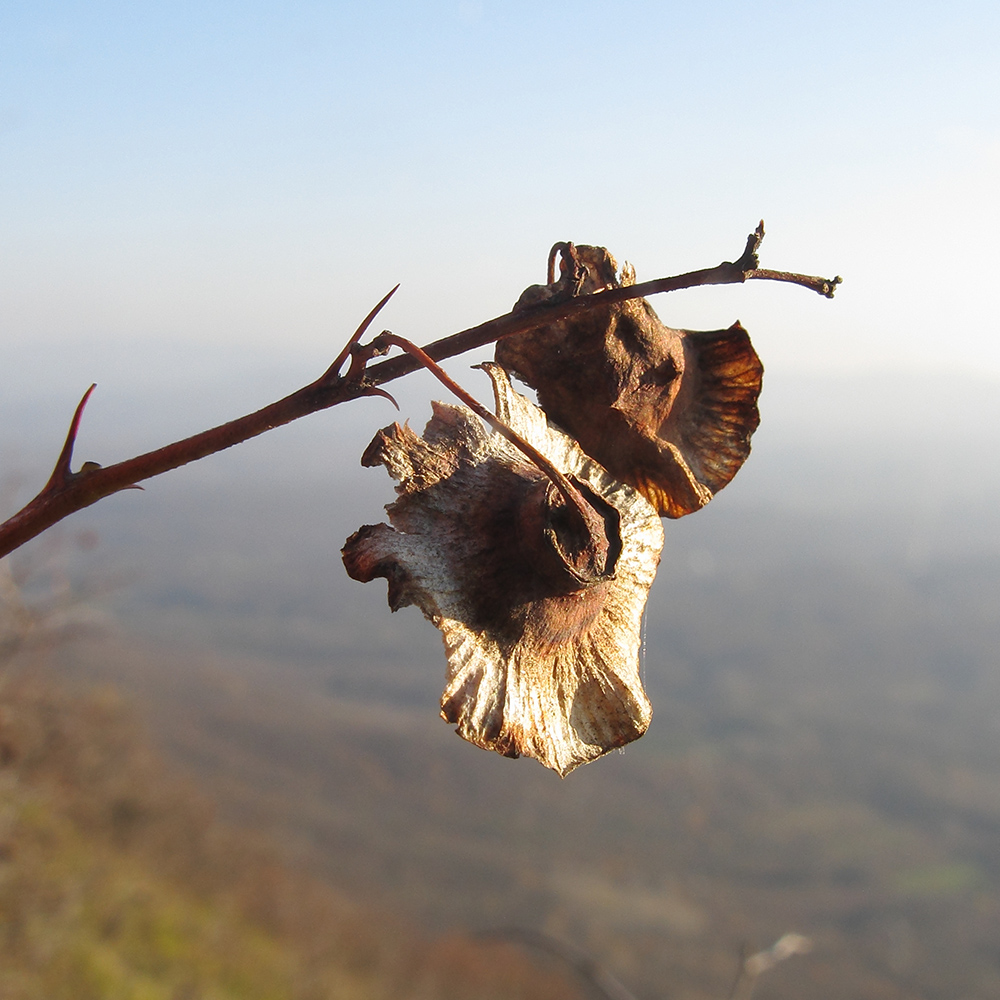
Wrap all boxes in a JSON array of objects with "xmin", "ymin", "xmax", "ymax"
[{"xmin": 0, "ymin": 223, "xmax": 840, "ymax": 557}]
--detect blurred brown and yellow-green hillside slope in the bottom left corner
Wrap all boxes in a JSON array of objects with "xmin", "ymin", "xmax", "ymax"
[{"xmin": 0, "ymin": 640, "xmax": 577, "ymax": 1000}]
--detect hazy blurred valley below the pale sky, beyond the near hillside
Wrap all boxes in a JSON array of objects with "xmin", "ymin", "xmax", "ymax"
[{"xmin": 0, "ymin": 373, "xmax": 1000, "ymax": 1000}]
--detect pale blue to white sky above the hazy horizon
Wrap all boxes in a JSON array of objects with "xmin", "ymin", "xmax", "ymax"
[{"xmin": 0, "ymin": 0, "xmax": 1000, "ymax": 468}]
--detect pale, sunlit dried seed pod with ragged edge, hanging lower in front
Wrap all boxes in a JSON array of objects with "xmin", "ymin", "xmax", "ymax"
[{"xmin": 343, "ymin": 364, "xmax": 663, "ymax": 775}]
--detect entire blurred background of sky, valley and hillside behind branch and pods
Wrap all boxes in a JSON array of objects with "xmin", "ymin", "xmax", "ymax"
[{"xmin": 0, "ymin": 0, "xmax": 1000, "ymax": 1000}]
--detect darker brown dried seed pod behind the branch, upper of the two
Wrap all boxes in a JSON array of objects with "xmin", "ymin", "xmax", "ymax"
[{"xmin": 496, "ymin": 244, "xmax": 764, "ymax": 517}]
